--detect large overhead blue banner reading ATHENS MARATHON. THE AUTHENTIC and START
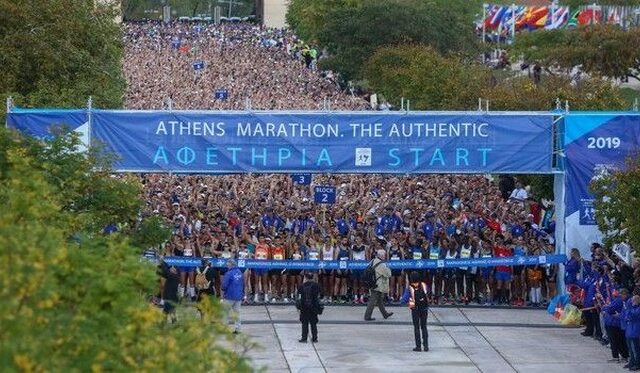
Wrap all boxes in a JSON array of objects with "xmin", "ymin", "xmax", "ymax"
[{"xmin": 92, "ymin": 110, "xmax": 552, "ymax": 173}]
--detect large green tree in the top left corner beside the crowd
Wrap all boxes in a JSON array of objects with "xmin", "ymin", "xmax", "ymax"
[{"xmin": 0, "ymin": 0, "xmax": 125, "ymax": 108}]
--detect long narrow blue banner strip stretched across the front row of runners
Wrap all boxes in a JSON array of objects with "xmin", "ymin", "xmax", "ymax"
[{"xmin": 154, "ymin": 255, "xmax": 567, "ymax": 270}]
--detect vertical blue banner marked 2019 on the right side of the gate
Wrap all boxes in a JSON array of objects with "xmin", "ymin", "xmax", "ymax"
[{"xmin": 564, "ymin": 113, "xmax": 640, "ymax": 257}]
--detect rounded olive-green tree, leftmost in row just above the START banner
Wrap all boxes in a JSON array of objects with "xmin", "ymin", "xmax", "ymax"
[{"xmin": 364, "ymin": 46, "xmax": 491, "ymax": 110}]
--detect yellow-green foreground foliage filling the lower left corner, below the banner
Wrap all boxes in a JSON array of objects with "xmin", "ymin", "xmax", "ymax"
[{"xmin": 0, "ymin": 129, "xmax": 250, "ymax": 372}]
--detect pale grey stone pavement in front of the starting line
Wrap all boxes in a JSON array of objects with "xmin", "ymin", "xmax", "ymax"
[{"xmin": 230, "ymin": 305, "xmax": 624, "ymax": 373}]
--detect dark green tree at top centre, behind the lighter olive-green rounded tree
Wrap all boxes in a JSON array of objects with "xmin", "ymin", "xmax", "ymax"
[{"xmin": 316, "ymin": 0, "xmax": 476, "ymax": 80}]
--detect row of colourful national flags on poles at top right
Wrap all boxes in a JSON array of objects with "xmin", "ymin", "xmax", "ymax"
[{"xmin": 478, "ymin": 4, "xmax": 640, "ymax": 41}]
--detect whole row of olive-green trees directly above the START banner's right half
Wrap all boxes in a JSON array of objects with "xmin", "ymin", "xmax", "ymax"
[{"xmin": 364, "ymin": 46, "xmax": 629, "ymax": 110}]
